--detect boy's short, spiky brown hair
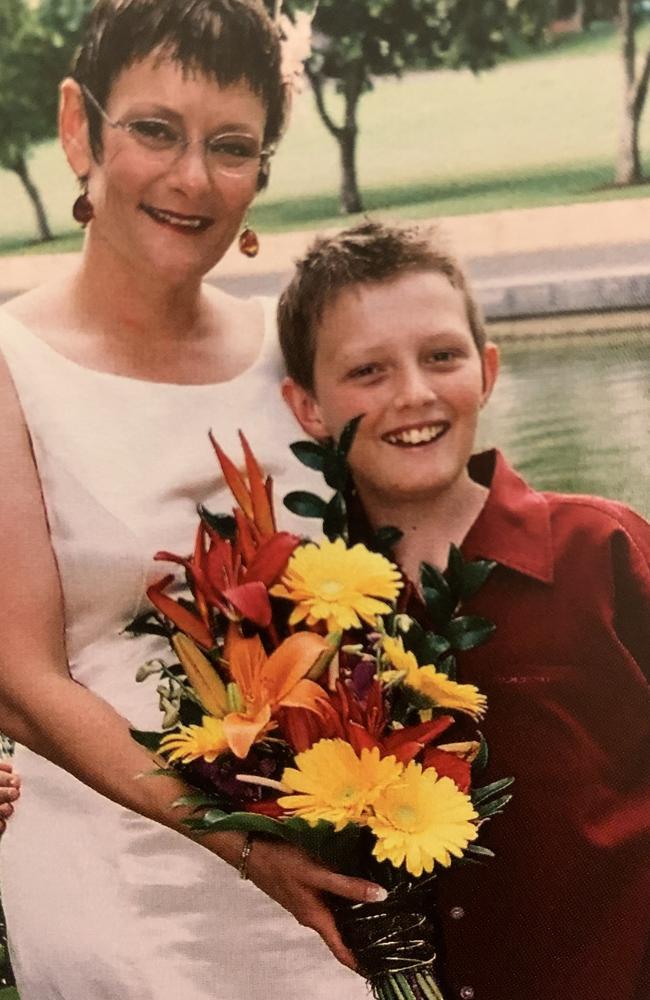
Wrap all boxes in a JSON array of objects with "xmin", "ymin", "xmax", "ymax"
[{"xmin": 278, "ymin": 222, "xmax": 486, "ymax": 392}]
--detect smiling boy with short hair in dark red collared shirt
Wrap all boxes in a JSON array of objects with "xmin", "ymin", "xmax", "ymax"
[{"xmin": 279, "ymin": 223, "xmax": 650, "ymax": 1000}]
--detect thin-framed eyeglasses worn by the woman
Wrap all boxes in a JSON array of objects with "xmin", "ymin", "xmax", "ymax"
[{"xmin": 81, "ymin": 84, "xmax": 273, "ymax": 177}]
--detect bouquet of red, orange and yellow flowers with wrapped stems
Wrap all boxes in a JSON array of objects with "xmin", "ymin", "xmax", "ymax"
[{"xmin": 129, "ymin": 421, "xmax": 510, "ymax": 1000}]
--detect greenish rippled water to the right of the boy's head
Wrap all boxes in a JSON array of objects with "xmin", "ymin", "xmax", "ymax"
[{"xmin": 480, "ymin": 330, "xmax": 650, "ymax": 517}]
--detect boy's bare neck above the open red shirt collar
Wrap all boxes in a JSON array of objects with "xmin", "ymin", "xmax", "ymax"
[{"xmin": 360, "ymin": 470, "xmax": 489, "ymax": 583}]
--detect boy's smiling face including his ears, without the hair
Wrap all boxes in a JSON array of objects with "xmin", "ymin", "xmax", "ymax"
[{"xmin": 285, "ymin": 271, "xmax": 498, "ymax": 508}]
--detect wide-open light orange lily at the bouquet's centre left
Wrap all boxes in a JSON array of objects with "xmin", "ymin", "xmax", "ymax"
[{"xmin": 224, "ymin": 628, "xmax": 330, "ymax": 758}]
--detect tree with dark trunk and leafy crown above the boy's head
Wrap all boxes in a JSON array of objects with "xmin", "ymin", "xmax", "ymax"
[{"xmin": 288, "ymin": 0, "xmax": 555, "ymax": 212}]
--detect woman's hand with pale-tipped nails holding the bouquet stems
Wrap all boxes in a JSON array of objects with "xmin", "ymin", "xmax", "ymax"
[{"xmin": 247, "ymin": 839, "xmax": 386, "ymax": 971}]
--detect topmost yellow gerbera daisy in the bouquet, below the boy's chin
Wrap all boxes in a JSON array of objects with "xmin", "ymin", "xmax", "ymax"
[{"xmin": 271, "ymin": 538, "xmax": 402, "ymax": 632}]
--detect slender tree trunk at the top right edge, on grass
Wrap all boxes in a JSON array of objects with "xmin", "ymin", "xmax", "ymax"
[{"xmin": 616, "ymin": 0, "xmax": 650, "ymax": 185}]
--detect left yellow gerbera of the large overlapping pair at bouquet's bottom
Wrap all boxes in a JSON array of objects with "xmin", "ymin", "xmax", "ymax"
[{"xmin": 278, "ymin": 739, "xmax": 404, "ymax": 830}]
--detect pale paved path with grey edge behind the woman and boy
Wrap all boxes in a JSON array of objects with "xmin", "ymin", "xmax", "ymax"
[{"xmin": 0, "ymin": 198, "xmax": 650, "ymax": 319}]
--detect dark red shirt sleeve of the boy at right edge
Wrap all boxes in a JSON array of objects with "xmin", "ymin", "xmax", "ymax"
[{"xmin": 612, "ymin": 510, "xmax": 650, "ymax": 682}]
